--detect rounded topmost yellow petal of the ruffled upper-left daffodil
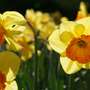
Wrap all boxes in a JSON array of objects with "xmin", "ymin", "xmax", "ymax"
[{"xmin": 2, "ymin": 11, "xmax": 26, "ymax": 28}]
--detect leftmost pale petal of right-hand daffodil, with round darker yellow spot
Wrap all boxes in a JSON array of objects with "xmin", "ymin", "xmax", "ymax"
[{"xmin": 49, "ymin": 26, "xmax": 74, "ymax": 53}]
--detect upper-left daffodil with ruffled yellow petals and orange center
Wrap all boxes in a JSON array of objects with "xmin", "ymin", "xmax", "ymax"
[{"xmin": 0, "ymin": 11, "xmax": 33, "ymax": 50}]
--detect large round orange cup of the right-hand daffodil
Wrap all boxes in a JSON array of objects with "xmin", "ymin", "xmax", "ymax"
[{"xmin": 66, "ymin": 35, "xmax": 90, "ymax": 64}]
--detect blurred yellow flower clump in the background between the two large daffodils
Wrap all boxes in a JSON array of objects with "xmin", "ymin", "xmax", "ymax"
[{"xmin": 26, "ymin": 9, "xmax": 55, "ymax": 40}]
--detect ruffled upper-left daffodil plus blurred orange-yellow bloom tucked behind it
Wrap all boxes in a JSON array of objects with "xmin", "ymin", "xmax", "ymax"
[{"xmin": 0, "ymin": 11, "xmax": 34, "ymax": 60}]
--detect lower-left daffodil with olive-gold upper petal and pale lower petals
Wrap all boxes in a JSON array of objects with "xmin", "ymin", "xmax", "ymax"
[{"xmin": 0, "ymin": 51, "xmax": 20, "ymax": 90}]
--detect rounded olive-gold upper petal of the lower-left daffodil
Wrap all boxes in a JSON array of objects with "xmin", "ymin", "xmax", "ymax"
[{"xmin": 0, "ymin": 51, "xmax": 20, "ymax": 80}]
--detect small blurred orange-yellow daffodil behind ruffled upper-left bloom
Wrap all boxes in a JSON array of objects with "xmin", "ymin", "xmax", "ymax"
[{"xmin": 17, "ymin": 37, "xmax": 34, "ymax": 61}]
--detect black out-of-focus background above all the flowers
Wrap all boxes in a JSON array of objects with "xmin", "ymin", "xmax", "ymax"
[{"xmin": 0, "ymin": 0, "xmax": 90, "ymax": 19}]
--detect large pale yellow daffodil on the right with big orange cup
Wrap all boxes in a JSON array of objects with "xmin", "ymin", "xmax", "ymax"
[{"xmin": 49, "ymin": 17, "xmax": 90, "ymax": 74}]
